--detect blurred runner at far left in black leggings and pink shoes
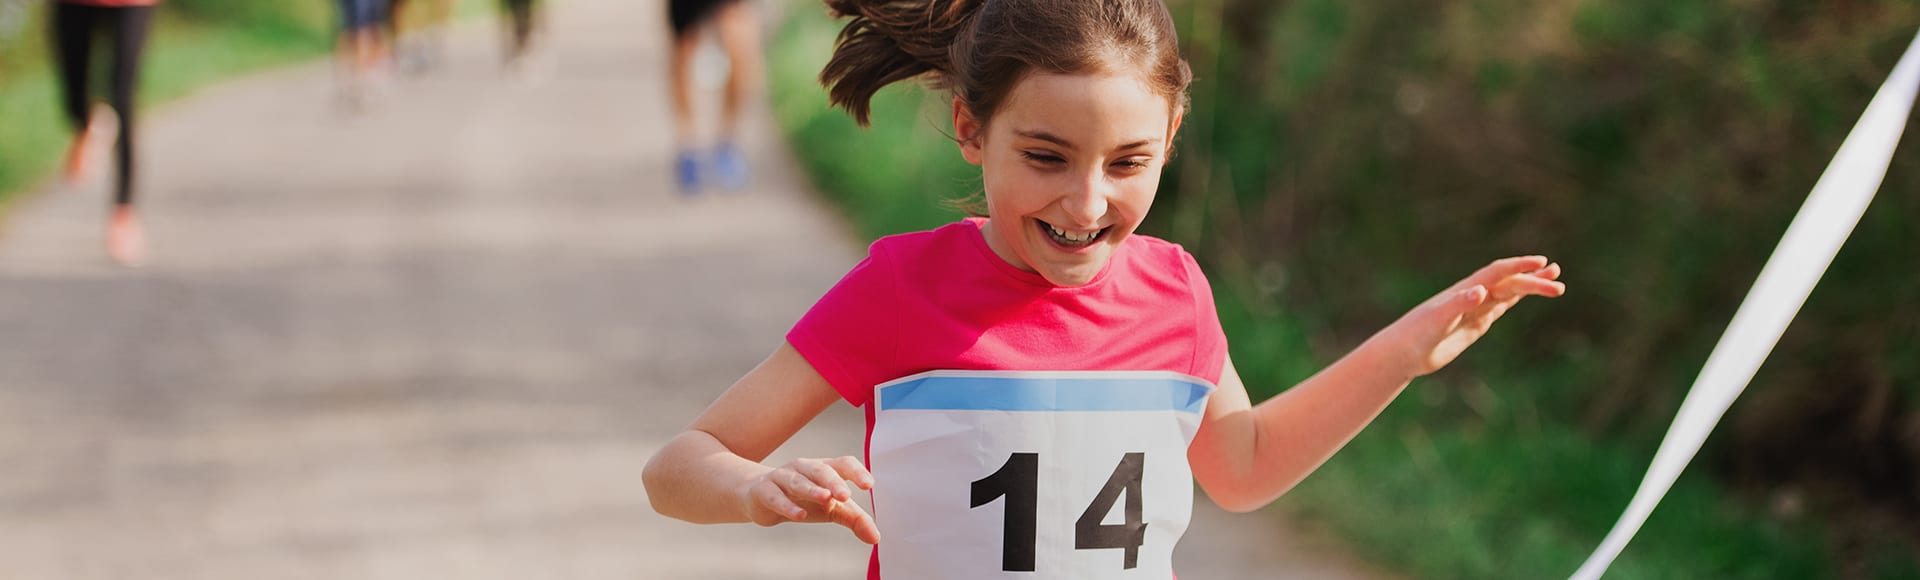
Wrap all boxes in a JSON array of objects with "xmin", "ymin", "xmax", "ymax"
[{"xmin": 50, "ymin": 0, "xmax": 159, "ymax": 265}]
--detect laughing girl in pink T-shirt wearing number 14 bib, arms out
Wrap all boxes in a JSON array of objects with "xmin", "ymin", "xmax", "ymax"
[{"xmin": 645, "ymin": 0, "xmax": 1565, "ymax": 580}]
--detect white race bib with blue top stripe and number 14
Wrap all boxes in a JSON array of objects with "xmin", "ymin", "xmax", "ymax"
[{"xmin": 868, "ymin": 371, "xmax": 1213, "ymax": 580}]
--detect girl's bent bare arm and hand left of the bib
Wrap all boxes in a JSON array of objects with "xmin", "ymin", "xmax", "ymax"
[{"xmin": 641, "ymin": 344, "xmax": 879, "ymax": 544}]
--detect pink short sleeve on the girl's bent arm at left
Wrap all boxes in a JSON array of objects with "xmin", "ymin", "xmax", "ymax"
[{"xmin": 787, "ymin": 240, "xmax": 899, "ymax": 407}]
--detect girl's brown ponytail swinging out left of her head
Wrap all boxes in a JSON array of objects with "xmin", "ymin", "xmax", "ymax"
[{"xmin": 820, "ymin": 0, "xmax": 987, "ymax": 127}]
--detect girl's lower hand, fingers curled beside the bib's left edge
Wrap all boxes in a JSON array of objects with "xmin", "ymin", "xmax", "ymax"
[{"xmin": 739, "ymin": 457, "xmax": 879, "ymax": 544}]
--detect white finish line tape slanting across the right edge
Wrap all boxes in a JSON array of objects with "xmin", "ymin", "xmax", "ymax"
[{"xmin": 1572, "ymin": 30, "xmax": 1920, "ymax": 580}]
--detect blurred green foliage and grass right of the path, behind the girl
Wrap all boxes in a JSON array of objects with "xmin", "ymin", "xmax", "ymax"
[{"xmin": 772, "ymin": 0, "xmax": 1920, "ymax": 578}]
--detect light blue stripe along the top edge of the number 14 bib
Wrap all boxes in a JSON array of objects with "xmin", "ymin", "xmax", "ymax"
[{"xmin": 879, "ymin": 373, "xmax": 1213, "ymax": 413}]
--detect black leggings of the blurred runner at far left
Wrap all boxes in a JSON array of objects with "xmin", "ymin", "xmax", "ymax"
[{"xmin": 52, "ymin": 2, "xmax": 154, "ymax": 205}]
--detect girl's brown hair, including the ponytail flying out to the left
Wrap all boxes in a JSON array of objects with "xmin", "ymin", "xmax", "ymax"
[{"xmin": 820, "ymin": 0, "xmax": 1192, "ymax": 125}]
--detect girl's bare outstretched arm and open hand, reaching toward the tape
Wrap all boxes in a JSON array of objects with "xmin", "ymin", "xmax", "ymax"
[{"xmin": 1187, "ymin": 255, "xmax": 1567, "ymax": 511}]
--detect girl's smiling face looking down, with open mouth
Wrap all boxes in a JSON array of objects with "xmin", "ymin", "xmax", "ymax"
[{"xmin": 954, "ymin": 71, "xmax": 1179, "ymax": 286}]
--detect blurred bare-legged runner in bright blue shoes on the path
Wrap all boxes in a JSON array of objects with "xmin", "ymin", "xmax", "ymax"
[{"xmin": 666, "ymin": 0, "xmax": 760, "ymax": 196}]
